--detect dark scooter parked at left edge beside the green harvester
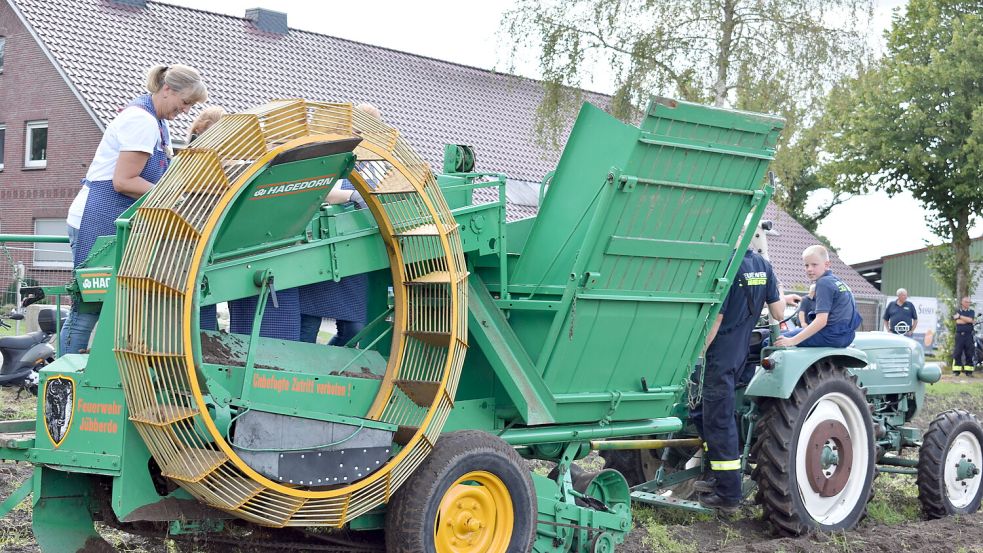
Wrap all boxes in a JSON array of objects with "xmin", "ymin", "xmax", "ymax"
[{"xmin": 0, "ymin": 288, "xmax": 65, "ymax": 395}]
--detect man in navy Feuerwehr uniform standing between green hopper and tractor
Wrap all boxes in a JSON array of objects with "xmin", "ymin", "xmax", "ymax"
[{"xmin": 692, "ymin": 250, "xmax": 797, "ymax": 512}]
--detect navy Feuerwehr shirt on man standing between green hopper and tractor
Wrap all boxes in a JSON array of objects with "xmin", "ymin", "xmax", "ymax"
[{"xmin": 707, "ymin": 250, "xmax": 781, "ymax": 366}]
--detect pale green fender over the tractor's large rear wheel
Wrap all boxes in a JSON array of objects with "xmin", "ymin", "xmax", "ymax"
[{"xmin": 744, "ymin": 348, "xmax": 867, "ymax": 399}]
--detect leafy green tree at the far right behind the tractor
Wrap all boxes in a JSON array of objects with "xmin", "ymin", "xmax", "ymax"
[{"xmin": 821, "ymin": 0, "xmax": 983, "ymax": 297}]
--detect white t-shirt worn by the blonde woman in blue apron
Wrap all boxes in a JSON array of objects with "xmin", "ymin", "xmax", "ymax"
[{"xmin": 66, "ymin": 106, "xmax": 170, "ymax": 228}]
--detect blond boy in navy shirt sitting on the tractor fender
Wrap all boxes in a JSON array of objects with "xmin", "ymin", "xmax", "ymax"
[{"xmin": 775, "ymin": 244, "xmax": 863, "ymax": 348}]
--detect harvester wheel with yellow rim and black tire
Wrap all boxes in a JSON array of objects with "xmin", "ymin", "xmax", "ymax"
[{"xmin": 386, "ymin": 430, "xmax": 537, "ymax": 553}]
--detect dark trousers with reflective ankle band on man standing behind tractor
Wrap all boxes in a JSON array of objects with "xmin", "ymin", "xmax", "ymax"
[{"xmin": 691, "ymin": 351, "xmax": 745, "ymax": 501}]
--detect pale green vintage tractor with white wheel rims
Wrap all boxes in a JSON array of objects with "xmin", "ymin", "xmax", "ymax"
[{"xmin": 601, "ymin": 222, "xmax": 983, "ymax": 536}]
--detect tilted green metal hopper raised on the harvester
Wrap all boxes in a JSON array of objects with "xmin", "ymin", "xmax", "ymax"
[{"xmin": 500, "ymin": 96, "xmax": 781, "ymax": 422}]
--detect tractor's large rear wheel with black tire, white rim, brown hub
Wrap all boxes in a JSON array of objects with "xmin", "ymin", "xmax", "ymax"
[{"xmin": 751, "ymin": 360, "xmax": 876, "ymax": 536}]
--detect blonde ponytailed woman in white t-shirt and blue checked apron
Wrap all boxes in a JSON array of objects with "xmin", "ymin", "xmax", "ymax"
[{"xmin": 61, "ymin": 65, "xmax": 208, "ymax": 353}]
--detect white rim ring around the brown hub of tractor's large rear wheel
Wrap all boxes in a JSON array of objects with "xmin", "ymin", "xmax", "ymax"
[{"xmin": 795, "ymin": 392, "xmax": 870, "ymax": 526}]
